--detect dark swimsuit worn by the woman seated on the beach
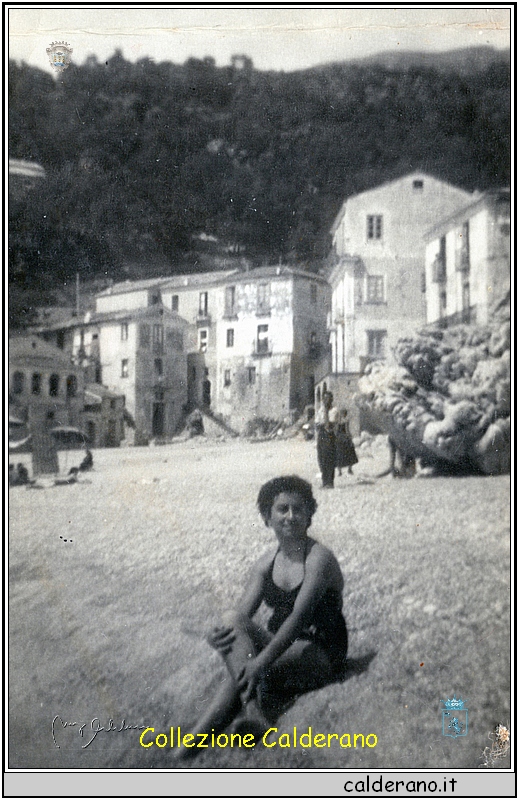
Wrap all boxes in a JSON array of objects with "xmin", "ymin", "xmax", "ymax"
[{"xmin": 263, "ymin": 550, "xmax": 348, "ymax": 672}]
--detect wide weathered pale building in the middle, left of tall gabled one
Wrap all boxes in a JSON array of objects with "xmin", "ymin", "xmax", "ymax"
[{"xmin": 97, "ymin": 266, "xmax": 330, "ymax": 432}]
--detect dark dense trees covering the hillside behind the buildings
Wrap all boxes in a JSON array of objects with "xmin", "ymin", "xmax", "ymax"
[{"xmin": 9, "ymin": 47, "xmax": 510, "ymax": 320}]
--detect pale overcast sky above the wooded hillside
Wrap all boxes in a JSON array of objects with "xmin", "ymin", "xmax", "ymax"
[{"xmin": 8, "ymin": 5, "xmax": 511, "ymax": 72}]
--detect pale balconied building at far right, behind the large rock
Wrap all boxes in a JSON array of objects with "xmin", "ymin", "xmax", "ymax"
[{"xmin": 425, "ymin": 189, "xmax": 510, "ymax": 325}]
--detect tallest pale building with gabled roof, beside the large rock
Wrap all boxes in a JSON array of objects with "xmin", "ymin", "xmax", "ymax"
[{"xmin": 317, "ymin": 172, "xmax": 480, "ymax": 424}]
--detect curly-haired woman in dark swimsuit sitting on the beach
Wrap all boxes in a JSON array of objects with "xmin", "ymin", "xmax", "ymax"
[{"xmin": 181, "ymin": 475, "xmax": 348, "ymax": 758}]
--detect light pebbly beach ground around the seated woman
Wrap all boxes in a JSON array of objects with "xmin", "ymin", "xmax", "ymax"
[{"xmin": 9, "ymin": 440, "xmax": 510, "ymax": 769}]
